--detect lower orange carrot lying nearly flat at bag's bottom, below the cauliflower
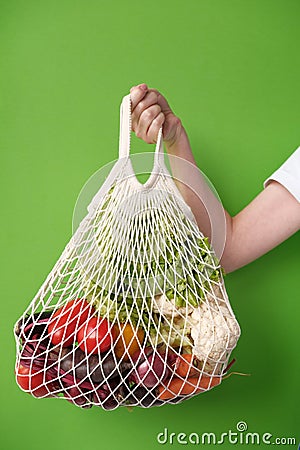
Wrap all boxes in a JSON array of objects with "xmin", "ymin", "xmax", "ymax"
[{"xmin": 157, "ymin": 375, "xmax": 222, "ymax": 400}]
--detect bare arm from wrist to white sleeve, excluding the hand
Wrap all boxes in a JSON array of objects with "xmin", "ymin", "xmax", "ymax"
[{"xmin": 166, "ymin": 129, "xmax": 300, "ymax": 272}]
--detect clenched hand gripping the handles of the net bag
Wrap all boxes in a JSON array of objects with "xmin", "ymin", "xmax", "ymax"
[{"xmin": 130, "ymin": 84, "xmax": 182, "ymax": 147}]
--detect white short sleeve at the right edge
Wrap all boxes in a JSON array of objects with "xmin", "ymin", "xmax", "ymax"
[{"xmin": 264, "ymin": 147, "xmax": 300, "ymax": 202}]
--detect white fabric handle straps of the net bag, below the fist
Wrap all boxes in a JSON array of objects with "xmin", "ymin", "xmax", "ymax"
[{"xmin": 119, "ymin": 94, "xmax": 164, "ymax": 168}]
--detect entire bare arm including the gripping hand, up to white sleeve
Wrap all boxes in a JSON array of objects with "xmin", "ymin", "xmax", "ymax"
[{"xmin": 130, "ymin": 84, "xmax": 300, "ymax": 272}]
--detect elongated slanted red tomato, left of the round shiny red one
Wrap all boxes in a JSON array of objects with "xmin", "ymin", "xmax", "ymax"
[{"xmin": 48, "ymin": 298, "xmax": 94, "ymax": 347}]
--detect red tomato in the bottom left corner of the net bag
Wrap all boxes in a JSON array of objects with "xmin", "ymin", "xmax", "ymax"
[{"xmin": 16, "ymin": 364, "xmax": 49, "ymax": 397}]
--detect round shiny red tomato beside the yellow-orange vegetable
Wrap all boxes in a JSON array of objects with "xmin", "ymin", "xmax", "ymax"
[{"xmin": 77, "ymin": 317, "xmax": 115, "ymax": 354}]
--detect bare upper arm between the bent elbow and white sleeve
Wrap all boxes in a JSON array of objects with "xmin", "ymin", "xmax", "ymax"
[{"xmin": 221, "ymin": 181, "xmax": 300, "ymax": 272}]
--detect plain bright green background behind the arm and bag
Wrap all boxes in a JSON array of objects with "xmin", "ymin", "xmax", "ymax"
[{"xmin": 0, "ymin": 0, "xmax": 300, "ymax": 450}]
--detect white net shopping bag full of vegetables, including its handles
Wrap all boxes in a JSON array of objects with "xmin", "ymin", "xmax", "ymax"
[{"xmin": 15, "ymin": 95, "xmax": 240, "ymax": 410}]
